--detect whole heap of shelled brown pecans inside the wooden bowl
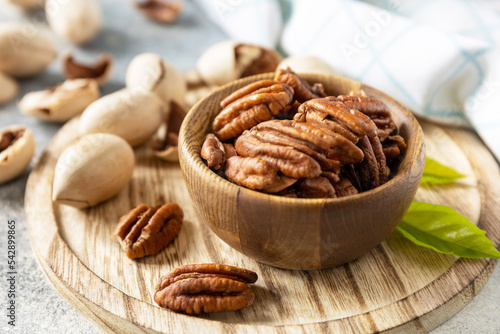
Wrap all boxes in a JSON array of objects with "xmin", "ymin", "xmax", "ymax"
[{"xmin": 201, "ymin": 68, "xmax": 406, "ymax": 198}]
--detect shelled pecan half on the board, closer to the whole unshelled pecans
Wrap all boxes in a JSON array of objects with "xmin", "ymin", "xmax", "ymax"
[{"xmin": 111, "ymin": 203, "xmax": 184, "ymax": 259}]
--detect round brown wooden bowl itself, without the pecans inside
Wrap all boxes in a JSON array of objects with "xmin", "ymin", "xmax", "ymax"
[{"xmin": 179, "ymin": 73, "xmax": 425, "ymax": 270}]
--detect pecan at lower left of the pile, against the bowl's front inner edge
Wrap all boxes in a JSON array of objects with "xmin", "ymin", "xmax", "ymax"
[{"xmin": 225, "ymin": 156, "xmax": 297, "ymax": 193}]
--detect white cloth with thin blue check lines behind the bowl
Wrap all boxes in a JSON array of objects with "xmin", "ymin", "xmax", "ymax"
[{"xmin": 195, "ymin": 0, "xmax": 500, "ymax": 160}]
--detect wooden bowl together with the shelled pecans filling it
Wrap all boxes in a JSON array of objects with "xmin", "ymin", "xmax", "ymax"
[{"xmin": 179, "ymin": 69, "xmax": 425, "ymax": 270}]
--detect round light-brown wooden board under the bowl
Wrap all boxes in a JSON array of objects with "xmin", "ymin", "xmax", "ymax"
[{"xmin": 26, "ymin": 119, "xmax": 500, "ymax": 333}]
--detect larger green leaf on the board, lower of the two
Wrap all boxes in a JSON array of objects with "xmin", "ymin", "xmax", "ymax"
[{"xmin": 398, "ymin": 202, "xmax": 500, "ymax": 259}]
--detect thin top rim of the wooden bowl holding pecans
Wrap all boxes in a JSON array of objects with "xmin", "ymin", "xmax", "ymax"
[{"xmin": 179, "ymin": 72, "xmax": 425, "ymax": 205}]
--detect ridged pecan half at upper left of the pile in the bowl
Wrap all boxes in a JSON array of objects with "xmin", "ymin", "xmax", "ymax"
[{"xmin": 212, "ymin": 80, "xmax": 293, "ymax": 141}]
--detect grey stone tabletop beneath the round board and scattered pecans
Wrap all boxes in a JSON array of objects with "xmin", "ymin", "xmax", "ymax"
[{"xmin": 0, "ymin": 0, "xmax": 500, "ymax": 334}]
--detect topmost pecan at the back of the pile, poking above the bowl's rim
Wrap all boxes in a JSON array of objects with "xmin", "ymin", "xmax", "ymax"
[{"xmin": 274, "ymin": 67, "xmax": 326, "ymax": 102}]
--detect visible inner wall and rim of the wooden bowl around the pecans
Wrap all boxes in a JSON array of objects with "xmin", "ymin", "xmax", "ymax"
[{"xmin": 180, "ymin": 73, "xmax": 423, "ymax": 203}]
